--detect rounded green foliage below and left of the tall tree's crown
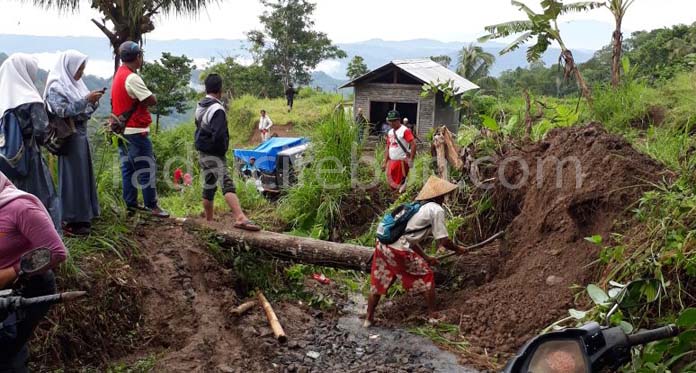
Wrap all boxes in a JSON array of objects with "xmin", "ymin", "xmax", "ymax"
[{"xmin": 201, "ymin": 57, "xmax": 283, "ymax": 98}]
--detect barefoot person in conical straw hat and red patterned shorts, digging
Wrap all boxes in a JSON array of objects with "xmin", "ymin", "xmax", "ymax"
[{"xmin": 364, "ymin": 176, "xmax": 466, "ymax": 327}]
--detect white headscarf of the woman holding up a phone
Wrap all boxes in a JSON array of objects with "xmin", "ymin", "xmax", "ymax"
[{"xmin": 44, "ymin": 49, "xmax": 89, "ymax": 110}]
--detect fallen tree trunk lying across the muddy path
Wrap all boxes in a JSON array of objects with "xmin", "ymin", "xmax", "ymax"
[{"xmin": 177, "ymin": 219, "xmax": 374, "ymax": 272}]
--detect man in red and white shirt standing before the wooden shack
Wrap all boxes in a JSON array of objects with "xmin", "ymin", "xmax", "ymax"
[{"xmin": 382, "ymin": 110, "xmax": 416, "ymax": 193}]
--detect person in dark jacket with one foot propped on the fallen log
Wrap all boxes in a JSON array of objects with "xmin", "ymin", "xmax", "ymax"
[{"xmin": 195, "ymin": 74, "xmax": 261, "ymax": 231}]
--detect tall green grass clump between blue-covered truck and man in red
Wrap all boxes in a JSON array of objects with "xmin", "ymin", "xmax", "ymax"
[{"xmin": 279, "ymin": 110, "xmax": 358, "ymax": 238}]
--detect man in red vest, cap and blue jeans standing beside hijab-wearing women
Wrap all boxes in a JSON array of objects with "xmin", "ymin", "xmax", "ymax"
[{"xmin": 111, "ymin": 41, "xmax": 169, "ymax": 218}]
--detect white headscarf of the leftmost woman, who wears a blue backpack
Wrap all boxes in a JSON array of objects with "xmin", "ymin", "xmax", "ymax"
[{"xmin": 0, "ymin": 53, "xmax": 43, "ymax": 115}]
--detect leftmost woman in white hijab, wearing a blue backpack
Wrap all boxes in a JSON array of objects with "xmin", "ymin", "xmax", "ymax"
[{"xmin": 0, "ymin": 53, "xmax": 61, "ymax": 231}]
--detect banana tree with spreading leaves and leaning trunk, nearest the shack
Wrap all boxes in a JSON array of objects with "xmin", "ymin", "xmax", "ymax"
[{"xmin": 479, "ymin": 0, "xmax": 604, "ymax": 105}]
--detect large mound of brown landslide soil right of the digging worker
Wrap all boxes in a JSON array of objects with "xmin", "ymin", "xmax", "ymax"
[{"xmin": 383, "ymin": 124, "xmax": 671, "ymax": 354}]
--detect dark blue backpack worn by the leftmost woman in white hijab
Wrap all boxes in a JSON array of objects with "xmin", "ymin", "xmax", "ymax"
[{"xmin": 0, "ymin": 111, "xmax": 29, "ymax": 179}]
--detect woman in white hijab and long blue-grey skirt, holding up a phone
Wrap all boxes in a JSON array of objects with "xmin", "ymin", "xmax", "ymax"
[{"xmin": 44, "ymin": 50, "xmax": 104, "ymax": 235}]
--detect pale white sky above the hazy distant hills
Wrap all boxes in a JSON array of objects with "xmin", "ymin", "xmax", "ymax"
[{"xmin": 0, "ymin": 0, "xmax": 696, "ymax": 49}]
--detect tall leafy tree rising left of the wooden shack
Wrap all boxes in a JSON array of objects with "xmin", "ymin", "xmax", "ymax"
[{"xmin": 247, "ymin": 0, "xmax": 346, "ymax": 85}]
